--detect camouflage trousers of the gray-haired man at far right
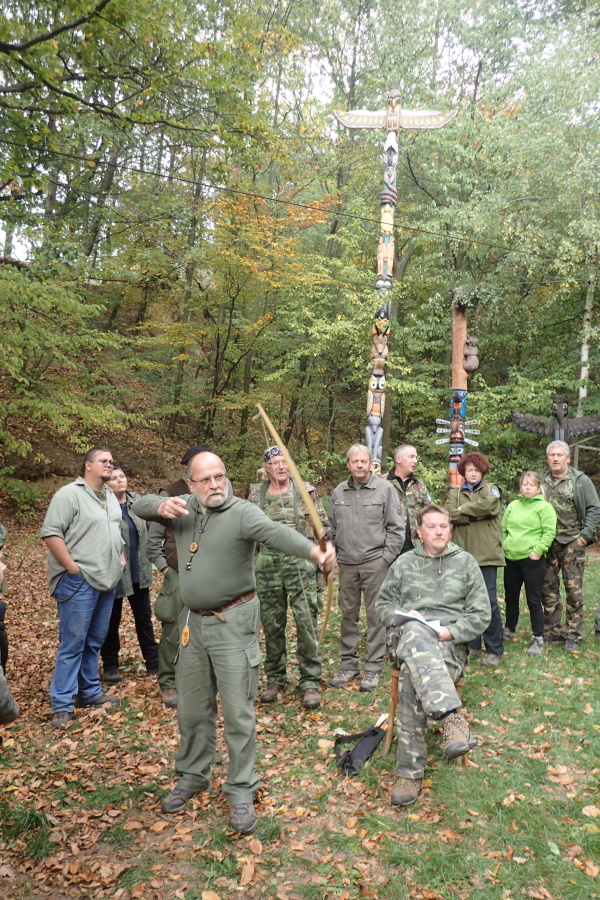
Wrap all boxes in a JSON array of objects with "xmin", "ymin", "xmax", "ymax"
[{"xmin": 542, "ymin": 538, "xmax": 585, "ymax": 640}]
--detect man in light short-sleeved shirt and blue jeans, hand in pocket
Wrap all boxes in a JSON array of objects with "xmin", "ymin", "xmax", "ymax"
[{"xmin": 41, "ymin": 447, "xmax": 125, "ymax": 730}]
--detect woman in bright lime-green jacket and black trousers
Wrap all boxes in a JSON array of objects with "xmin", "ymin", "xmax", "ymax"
[{"xmin": 502, "ymin": 472, "xmax": 556, "ymax": 656}]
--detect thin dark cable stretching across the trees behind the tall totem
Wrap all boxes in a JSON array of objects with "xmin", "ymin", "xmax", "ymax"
[{"xmin": 0, "ymin": 138, "xmax": 584, "ymax": 268}]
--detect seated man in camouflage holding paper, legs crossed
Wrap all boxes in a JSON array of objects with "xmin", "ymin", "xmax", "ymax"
[{"xmin": 375, "ymin": 506, "xmax": 490, "ymax": 806}]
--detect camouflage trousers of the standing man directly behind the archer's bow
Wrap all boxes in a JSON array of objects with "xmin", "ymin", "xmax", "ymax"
[{"xmin": 255, "ymin": 547, "xmax": 322, "ymax": 690}]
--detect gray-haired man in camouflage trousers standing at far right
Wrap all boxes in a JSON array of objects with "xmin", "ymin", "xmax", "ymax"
[{"xmin": 542, "ymin": 441, "xmax": 600, "ymax": 652}]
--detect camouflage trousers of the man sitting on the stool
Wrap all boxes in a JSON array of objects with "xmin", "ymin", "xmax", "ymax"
[{"xmin": 395, "ymin": 623, "xmax": 468, "ymax": 781}]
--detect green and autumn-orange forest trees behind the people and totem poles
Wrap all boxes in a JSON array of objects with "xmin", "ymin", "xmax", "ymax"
[{"xmin": 0, "ymin": 0, "xmax": 600, "ymax": 509}]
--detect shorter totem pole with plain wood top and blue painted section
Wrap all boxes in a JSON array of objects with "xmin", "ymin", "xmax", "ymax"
[{"xmin": 435, "ymin": 290, "xmax": 479, "ymax": 487}]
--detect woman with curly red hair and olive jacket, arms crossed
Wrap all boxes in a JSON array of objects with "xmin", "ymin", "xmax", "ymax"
[{"xmin": 446, "ymin": 452, "xmax": 506, "ymax": 666}]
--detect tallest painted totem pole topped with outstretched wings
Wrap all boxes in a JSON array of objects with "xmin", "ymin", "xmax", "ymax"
[{"xmin": 334, "ymin": 90, "xmax": 456, "ymax": 474}]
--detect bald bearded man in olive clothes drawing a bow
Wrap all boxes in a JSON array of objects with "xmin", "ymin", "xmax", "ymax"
[{"xmin": 132, "ymin": 453, "xmax": 335, "ymax": 833}]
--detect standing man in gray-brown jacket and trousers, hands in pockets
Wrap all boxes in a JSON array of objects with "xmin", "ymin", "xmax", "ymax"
[{"xmin": 329, "ymin": 444, "xmax": 404, "ymax": 691}]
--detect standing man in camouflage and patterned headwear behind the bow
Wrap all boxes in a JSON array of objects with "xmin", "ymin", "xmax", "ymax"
[{"xmin": 248, "ymin": 447, "xmax": 329, "ymax": 709}]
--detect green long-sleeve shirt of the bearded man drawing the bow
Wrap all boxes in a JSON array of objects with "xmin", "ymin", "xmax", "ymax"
[{"xmin": 132, "ymin": 485, "xmax": 315, "ymax": 609}]
